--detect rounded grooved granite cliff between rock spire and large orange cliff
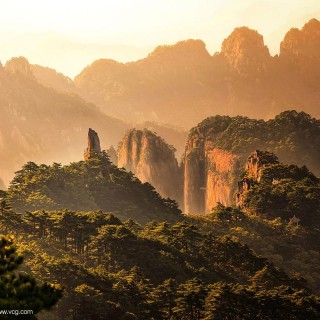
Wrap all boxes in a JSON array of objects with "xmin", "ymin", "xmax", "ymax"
[{"xmin": 118, "ymin": 129, "xmax": 181, "ymax": 202}]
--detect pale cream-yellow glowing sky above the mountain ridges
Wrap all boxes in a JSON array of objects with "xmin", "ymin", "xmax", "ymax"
[{"xmin": 0, "ymin": 0, "xmax": 320, "ymax": 77}]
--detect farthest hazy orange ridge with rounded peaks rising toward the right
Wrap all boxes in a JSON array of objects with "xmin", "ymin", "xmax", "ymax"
[{"xmin": 71, "ymin": 19, "xmax": 320, "ymax": 127}]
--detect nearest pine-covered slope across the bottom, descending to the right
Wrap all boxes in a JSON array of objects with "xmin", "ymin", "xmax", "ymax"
[{"xmin": 1, "ymin": 206, "xmax": 320, "ymax": 320}]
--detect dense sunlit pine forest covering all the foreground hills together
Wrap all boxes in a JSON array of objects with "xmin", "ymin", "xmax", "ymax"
[{"xmin": 1, "ymin": 142, "xmax": 320, "ymax": 320}]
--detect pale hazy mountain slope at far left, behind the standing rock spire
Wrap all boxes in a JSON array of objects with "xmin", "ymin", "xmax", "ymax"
[{"xmin": 0, "ymin": 58, "xmax": 128, "ymax": 182}]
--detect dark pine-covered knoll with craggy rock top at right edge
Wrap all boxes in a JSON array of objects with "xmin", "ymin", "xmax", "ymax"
[{"xmin": 236, "ymin": 151, "xmax": 320, "ymax": 227}]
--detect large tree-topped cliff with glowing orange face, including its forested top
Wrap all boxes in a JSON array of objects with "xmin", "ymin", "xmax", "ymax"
[{"xmin": 183, "ymin": 111, "xmax": 320, "ymax": 213}]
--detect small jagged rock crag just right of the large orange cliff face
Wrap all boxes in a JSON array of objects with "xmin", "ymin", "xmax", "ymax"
[{"xmin": 236, "ymin": 150, "xmax": 279, "ymax": 210}]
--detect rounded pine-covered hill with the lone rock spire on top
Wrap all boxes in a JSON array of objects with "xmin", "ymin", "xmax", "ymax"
[{"xmin": 7, "ymin": 153, "xmax": 181, "ymax": 223}]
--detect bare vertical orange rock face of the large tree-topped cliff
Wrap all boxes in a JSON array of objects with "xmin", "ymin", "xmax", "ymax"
[{"xmin": 184, "ymin": 136, "xmax": 239, "ymax": 213}]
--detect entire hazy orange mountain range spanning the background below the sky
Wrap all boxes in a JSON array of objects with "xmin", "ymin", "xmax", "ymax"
[{"xmin": 0, "ymin": 19, "xmax": 320, "ymax": 183}]
